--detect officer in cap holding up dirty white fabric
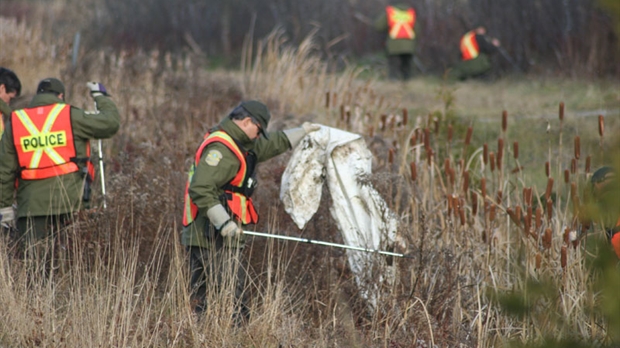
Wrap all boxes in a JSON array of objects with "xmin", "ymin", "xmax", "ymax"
[{"xmin": 181, "ymin": 100, "xmax": 320, "ymax": 324}]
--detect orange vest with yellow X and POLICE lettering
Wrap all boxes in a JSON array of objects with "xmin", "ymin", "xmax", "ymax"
[{"xmin": 11, "ymin": 103, "xmax": 94, "ymax": 180}]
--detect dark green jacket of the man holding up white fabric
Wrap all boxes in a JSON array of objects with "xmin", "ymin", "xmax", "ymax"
[{"xmin": 181, "ymin": 118, "xmax": 291, "ymax": 248}]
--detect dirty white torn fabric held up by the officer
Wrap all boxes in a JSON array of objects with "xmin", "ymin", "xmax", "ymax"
[{"xmin": 280, "ymin": 126, "xmax": 398, "ymax": 306}]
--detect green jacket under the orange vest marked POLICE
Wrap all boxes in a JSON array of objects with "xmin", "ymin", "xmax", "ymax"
[{"xmin": 0, "ymin": 93, "xmax": 120, "ymax": 218}]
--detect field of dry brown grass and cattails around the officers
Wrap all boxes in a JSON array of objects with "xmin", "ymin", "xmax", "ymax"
[{"xmin": 0, "ymin": 14, "xmax": 620, "ymax": 347}]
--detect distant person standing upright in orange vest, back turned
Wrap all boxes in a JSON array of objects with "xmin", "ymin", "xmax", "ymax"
[{"xmin": 375, "ymin": 4, "xmax": 419, "ymax": 80}]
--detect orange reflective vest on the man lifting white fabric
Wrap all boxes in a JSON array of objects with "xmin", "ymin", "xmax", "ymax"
[{"xmin": 183, "ymin": 130, "xmax": 258, "ymax": 226}]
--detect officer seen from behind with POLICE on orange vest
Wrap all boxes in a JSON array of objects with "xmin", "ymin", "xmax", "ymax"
[{"xmin": 0, "ymin": 78, "xmax": 120, "ymax": 245}]
